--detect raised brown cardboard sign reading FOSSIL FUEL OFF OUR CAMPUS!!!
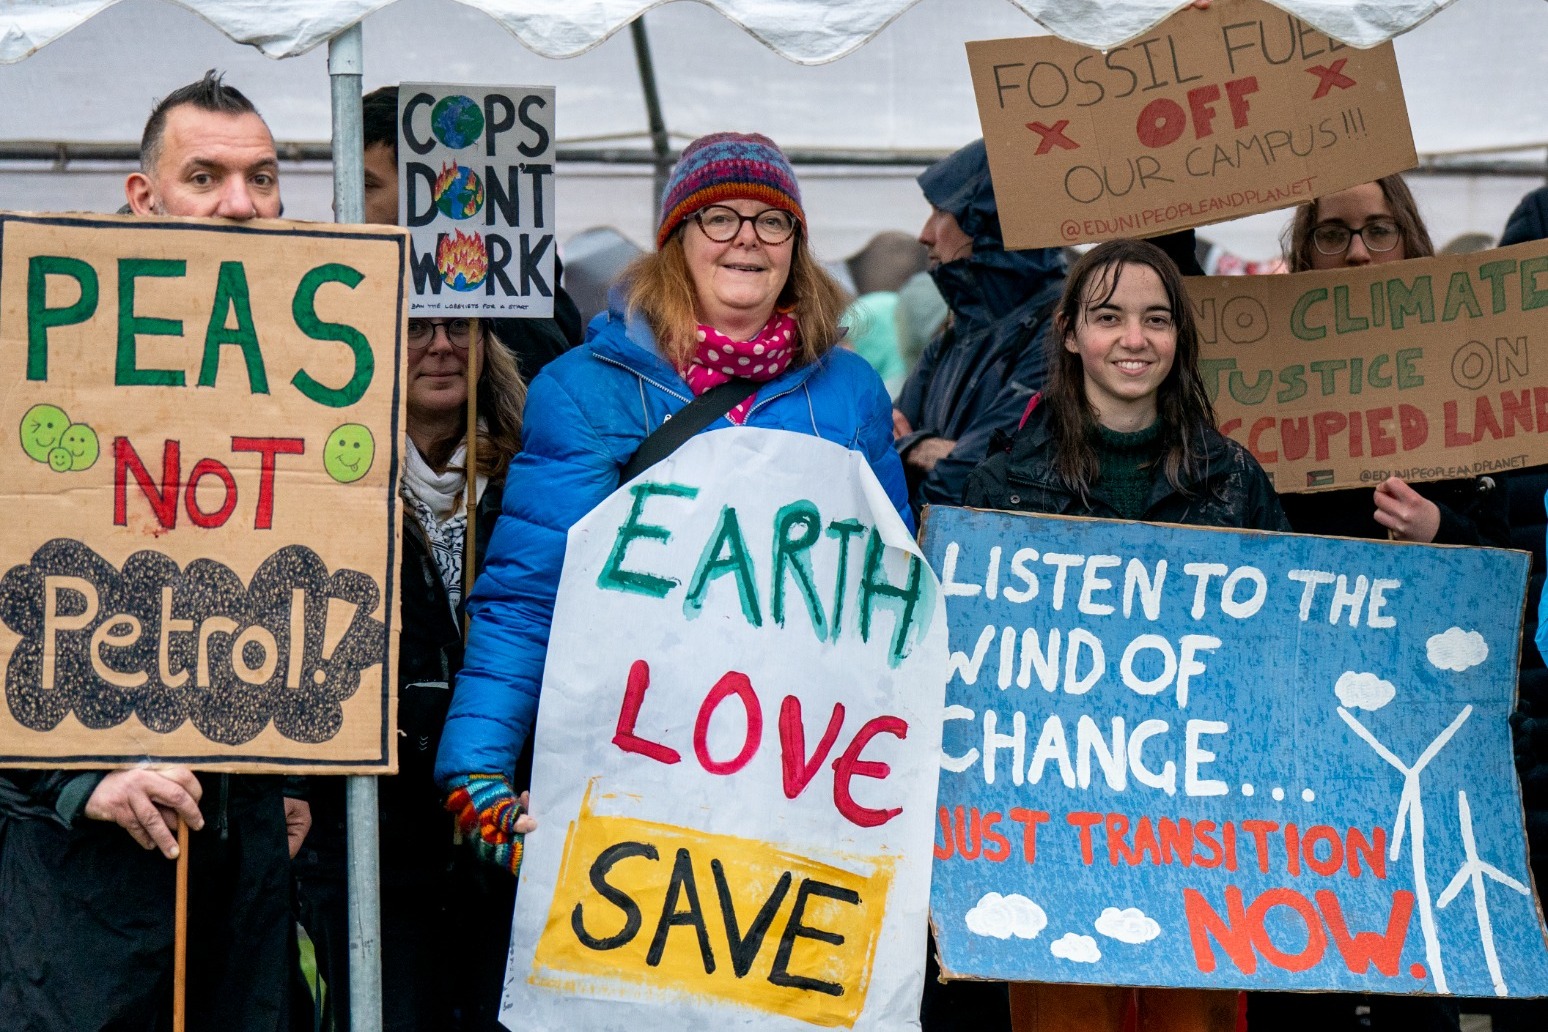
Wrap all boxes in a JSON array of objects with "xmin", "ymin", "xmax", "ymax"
[{"xmin": 968, "ymin": 0, "xmax": 1418, "ymax": 248}]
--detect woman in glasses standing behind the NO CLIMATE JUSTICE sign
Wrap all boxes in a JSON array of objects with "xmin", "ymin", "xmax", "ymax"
[{"xmin": 1248, "ymin": 175, "xmax": 1509, "ymax": 1032}]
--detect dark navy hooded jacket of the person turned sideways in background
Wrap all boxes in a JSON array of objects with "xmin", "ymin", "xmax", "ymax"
[{"xmin": 896, "ymin": 139, "xmax": 1065, "ymax": 509}]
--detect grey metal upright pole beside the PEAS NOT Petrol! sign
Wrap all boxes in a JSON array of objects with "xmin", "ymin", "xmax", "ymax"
[{"xmin": 328, "ymin": 23, "xmax": 387, "ymax": 1032}]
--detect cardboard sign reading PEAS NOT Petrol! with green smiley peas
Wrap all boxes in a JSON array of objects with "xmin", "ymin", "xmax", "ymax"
[{"xmin": 0, "ymin": 215, "xmax": 407, "ymax": 774}]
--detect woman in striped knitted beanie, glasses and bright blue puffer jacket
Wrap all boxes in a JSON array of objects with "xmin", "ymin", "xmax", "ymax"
[{"xmin": 437, "ymin": 133, "xmax": 913, "ymax": 873}]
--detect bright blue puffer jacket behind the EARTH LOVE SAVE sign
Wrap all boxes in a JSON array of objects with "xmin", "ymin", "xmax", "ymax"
[{"xmin": 435, "ymin": 309, "xmax": 913, "ymax": 783}]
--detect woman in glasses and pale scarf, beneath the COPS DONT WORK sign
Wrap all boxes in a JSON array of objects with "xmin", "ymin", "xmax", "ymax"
[{"xmin": 296, "ymin": 319, "xmax": 526, "ymax": 1030}]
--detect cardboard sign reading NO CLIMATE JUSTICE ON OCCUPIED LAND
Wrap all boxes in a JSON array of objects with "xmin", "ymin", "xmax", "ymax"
[{"xmin": 1187, "ymin": 241, "xmax": 1548, "ymax": 492}]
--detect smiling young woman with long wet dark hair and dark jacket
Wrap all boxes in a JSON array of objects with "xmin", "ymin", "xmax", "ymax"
[{"xmin": 966, "ymin": 240, "xmax": 1289, "ymax": 1032}]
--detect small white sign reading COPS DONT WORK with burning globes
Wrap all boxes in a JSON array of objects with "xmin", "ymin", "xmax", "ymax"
[{"xmin": 398, "ymin": 82, "xmax": 557, "ymax": 319}]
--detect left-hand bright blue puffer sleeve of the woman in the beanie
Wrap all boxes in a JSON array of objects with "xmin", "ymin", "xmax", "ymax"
[{"xmin": 435, "ymin": 373, "xmax": 618, "ymax": 784}]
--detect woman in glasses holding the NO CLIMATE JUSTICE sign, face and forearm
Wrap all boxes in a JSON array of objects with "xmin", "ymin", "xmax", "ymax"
[{"xmin": 1280, "ymin": 175, "xmax": 1509, "ymax": 548}]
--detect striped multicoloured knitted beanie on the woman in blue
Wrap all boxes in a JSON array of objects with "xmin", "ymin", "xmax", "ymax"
[{"xmin": 656, "ymin": 133, "xmax": 807, "ymax": 251}]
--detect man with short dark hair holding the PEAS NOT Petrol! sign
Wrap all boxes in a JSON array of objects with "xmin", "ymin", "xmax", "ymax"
[{"xmin": 0, "ymin": 71, "xmax": 300, "ymax": 1032}]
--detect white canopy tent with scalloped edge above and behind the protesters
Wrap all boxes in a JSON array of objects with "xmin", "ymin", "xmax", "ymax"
[{"xmin": 9, "ymin": 0, "xmax": 1548, "ymax": 258}]
